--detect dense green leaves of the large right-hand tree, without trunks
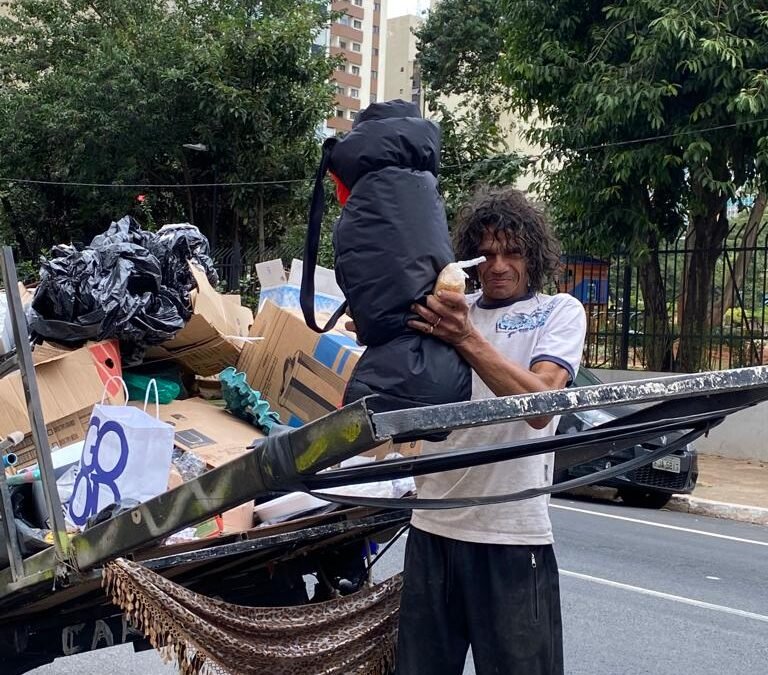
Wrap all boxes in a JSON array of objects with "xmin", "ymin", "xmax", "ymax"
[{"xmin": 499, "ymin": 0, "xmax": 768, "ymax": 252}]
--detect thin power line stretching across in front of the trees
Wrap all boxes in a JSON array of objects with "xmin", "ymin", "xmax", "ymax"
[{"xmin": 0, "ymin": 117, "xmax": 768, "ymax": 190}]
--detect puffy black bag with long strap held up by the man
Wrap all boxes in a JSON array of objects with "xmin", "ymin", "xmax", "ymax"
[{"xmin": 301, "ymin": 100, "xmax": 472, "ymax": 440}]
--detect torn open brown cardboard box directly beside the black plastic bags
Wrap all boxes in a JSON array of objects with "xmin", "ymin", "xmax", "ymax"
[{"xmin": 145, "ymin": 263, "xmax": 253, "ymax": 376}]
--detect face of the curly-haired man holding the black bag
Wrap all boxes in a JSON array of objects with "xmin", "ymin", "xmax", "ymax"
[{"xmin": 477, "ymin": 228, "xmax": 528, "ymax": 300}]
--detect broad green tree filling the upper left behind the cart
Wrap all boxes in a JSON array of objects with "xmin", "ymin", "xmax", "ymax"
[{"xmin": 0, "ymin": 0, "xmax": 333, "ymax": 256}]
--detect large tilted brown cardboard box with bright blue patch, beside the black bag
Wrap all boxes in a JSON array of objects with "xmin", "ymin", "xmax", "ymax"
[{"xmin": 237, "ymin": 301, "xmax": 421, "ymax": 457}]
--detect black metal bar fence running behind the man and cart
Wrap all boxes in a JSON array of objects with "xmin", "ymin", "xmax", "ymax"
[{"xmin": 214, "ymin": 219, "xmax": 768, "ymax": 370}]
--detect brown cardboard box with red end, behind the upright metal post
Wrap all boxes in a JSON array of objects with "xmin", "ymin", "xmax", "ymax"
[{"xmin": 0, "ymin": 340, "xmax": 122, "ymax": 467}]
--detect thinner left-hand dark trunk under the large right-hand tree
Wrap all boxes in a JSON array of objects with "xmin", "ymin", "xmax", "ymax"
[{"xmin": 637, "ymin": 240, "xmax": 672, "ymax": 371}]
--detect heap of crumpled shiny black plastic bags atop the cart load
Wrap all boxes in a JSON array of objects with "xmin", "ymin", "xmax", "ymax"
[{"xmin": 29, "ymin": 216, "xmax": 217, "ymax": 366}]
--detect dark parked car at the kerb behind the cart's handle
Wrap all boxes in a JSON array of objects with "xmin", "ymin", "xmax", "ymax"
[{"xmin": 555, "ymin": 368, "xmax": 699, "ymax": 509}]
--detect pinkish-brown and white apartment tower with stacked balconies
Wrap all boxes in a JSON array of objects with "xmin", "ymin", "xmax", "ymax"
[{"xmin": 326, "ymin": 0, "xmax": 387, "ymax": 135}]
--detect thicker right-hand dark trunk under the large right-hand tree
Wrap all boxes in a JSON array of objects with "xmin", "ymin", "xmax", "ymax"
[{"xmin": 677, "ymin": 195, "xmax": 728, "ymax": 373}]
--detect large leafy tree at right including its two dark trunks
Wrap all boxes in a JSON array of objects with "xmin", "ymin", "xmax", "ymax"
[{"xmin": 426, "ymin": 0, "xmax": 768, "ymax": 371}]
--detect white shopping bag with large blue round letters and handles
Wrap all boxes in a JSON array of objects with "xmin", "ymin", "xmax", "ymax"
[{"xmin": 67, "ymin": 377, "xmax": 173, "ymax": 527}]
